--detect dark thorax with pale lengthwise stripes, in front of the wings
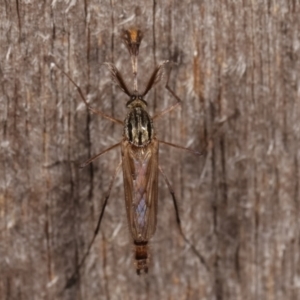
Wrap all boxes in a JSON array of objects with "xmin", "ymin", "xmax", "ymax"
[{"xmin": 124, "ymin": 100, "xmax": 154, "ymax": 147}]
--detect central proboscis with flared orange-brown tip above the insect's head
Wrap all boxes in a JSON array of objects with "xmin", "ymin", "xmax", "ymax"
[{"xmin": 122, "ymin": 29, "xmax": 143, "ymax": 94}]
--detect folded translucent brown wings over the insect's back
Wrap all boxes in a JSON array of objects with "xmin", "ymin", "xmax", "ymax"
[{"xmin": 122, "ymin": 139, "xmax": 158, "ymax": 242}]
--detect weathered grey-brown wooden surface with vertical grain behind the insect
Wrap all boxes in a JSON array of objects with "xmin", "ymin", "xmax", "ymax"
[{"xmin": 0, "ymin": 0, "xmax": 300, "ymax": 300}]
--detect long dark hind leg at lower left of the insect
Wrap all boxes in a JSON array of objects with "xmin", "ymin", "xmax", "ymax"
[{"xmin": 65, "ymin": 161, "xmax": 122, "ymax": 289}]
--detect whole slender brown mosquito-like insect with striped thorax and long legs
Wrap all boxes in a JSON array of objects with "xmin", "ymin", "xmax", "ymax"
[{"xmin": 54, "ymin": 29, "xmax": 204, "ymax": 279}]
